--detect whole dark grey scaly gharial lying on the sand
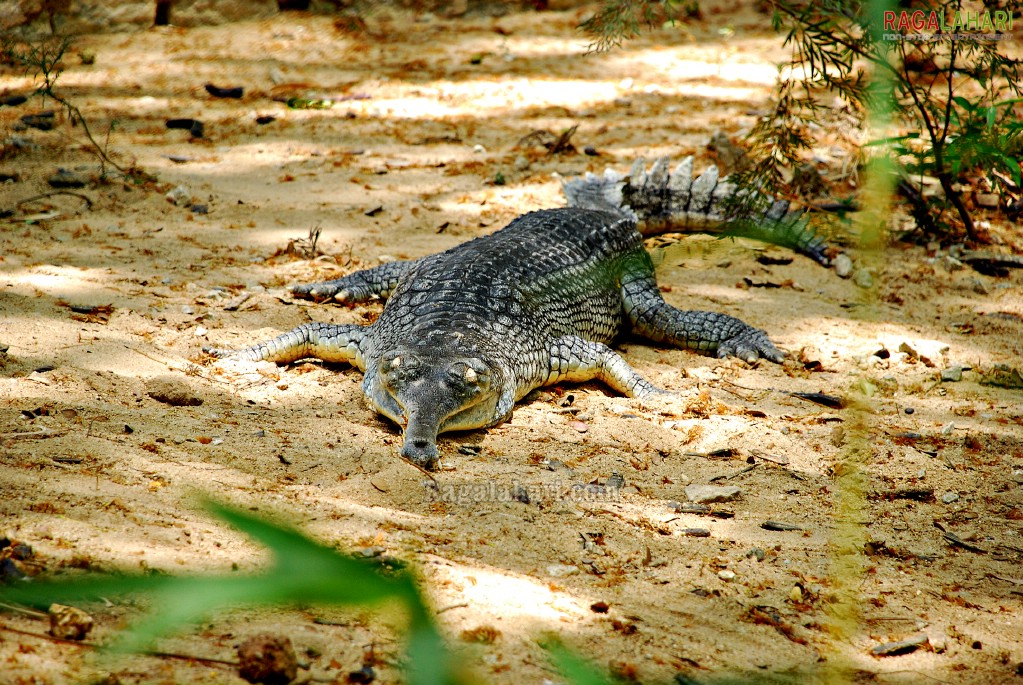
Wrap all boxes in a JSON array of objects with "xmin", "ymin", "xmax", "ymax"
[{"xmin": 205, "ymin": 157, "xmax": 827, "ymax": 468}]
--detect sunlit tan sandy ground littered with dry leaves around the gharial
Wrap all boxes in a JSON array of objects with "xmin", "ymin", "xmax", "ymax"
[{"xmin": 0, "ymin": 7, "xmax": 1023, "ymax": 683}]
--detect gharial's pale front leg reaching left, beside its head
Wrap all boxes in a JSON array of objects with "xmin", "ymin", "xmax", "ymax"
[{"xmin": 203, "ymin": 322, "xmax": 366, "ymax": 370}]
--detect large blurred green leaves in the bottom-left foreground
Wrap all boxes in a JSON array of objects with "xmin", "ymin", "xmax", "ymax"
[{"xmin": 0, "ymin": 503, "xmax": 459, "ymax": 685}]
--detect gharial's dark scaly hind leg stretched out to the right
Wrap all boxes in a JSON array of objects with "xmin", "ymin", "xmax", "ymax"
[{"xmin": 622, "ymin": 272, "xmax": 785, "ymax": 364}]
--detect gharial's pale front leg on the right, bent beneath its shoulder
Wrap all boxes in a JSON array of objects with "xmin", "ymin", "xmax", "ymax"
[{"xmin": 540, "ymin": 335, "xmax": 666, "ymax": 398}]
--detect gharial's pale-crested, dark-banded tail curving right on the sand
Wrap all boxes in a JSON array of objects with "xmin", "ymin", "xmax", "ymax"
[{"xmin": 563, "ymin": 156, "xmax": 830, "ymax": 266}]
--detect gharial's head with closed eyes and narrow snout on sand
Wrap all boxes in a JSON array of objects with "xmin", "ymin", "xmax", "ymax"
[{"xmin": 365, "ymin": 348, "xmax": 504, "ymax": 468}]
